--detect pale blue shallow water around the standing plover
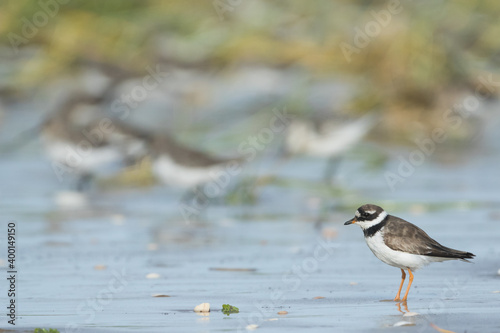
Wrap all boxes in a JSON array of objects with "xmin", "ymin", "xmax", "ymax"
[{"xmin": 0, "ymin": 104, "xmax": 500, "ymax": 332}]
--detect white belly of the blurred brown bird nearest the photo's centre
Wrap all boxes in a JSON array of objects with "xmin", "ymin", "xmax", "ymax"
[{"xmin": 153, "ymin": 155, "xmax": 223, "ymax": 187}]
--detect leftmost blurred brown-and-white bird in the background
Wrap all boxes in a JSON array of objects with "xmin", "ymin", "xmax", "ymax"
[{"xmin": 41, "ymin": 95, "xmax": 149, "ymax": 191}]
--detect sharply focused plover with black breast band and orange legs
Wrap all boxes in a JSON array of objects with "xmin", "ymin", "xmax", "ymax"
[{"xmin": 344, "ymin": 204, "xmax": 475, "ymax": 302}]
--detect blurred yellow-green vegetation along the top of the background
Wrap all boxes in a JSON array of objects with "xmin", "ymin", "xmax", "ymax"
[{"xmin": 0, "ymin": 0, "xmax": 500, "ymax": 134}]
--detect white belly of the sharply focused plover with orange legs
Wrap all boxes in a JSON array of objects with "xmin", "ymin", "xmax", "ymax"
[{"xmin": 365, "ymin": 229, "xmax": 449, "ymax": 271}]
